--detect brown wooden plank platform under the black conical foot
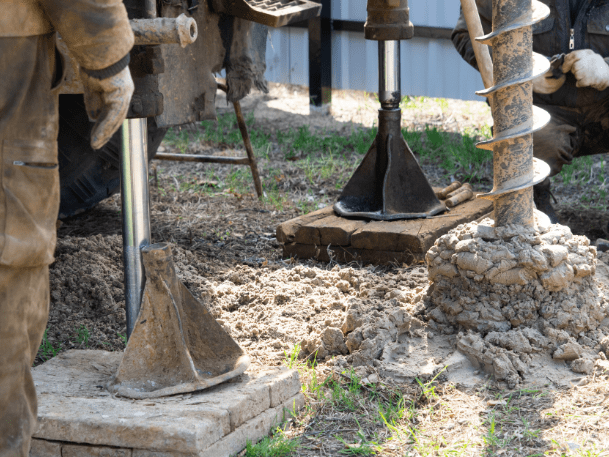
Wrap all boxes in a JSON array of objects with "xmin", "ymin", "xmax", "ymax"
[{"xmin": 277, "ymin": 194, "xmax": 493, "ymax": 265}]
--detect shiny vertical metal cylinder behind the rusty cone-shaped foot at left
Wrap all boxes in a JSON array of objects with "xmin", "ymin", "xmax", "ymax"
[{"xmin": 121, "ymin": 118, "xmax": 150, "ymax": 338}]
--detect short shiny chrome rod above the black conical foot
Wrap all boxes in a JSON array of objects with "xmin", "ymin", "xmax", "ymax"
[{"xmin": 379, "ymin": 41, "xmax": 401, "ymax": 110}]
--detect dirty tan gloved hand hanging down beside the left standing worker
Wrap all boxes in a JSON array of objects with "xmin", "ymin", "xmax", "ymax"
[{"xmin": 80, "ymin": 67, "xmax": 134, "ymax": 149}]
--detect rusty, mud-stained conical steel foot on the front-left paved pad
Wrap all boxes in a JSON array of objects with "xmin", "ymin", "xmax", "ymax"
[{"xmin": 108, "ymin": 243, "xmax": 250, "ymax": 399}]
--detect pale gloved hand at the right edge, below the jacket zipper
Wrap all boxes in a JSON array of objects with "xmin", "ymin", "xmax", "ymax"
[{"xmin": 562, "ymin": 49, "xmax": 609, "ymax": 90}]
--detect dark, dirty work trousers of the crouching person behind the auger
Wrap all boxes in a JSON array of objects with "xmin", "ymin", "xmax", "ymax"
[{"xmin": 533, "ymin": 100, "xmax": 609, "ymax": 176}]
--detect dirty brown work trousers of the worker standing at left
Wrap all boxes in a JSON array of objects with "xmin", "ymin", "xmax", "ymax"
[{"xmin": 0, "ymin": 34, "xmax": 59, "ymax": 457}]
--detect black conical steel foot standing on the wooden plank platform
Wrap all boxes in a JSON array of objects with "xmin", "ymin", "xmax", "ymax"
[{"xmin": 334, "ymin": 109, "xmax": 446, "ymax": 221}]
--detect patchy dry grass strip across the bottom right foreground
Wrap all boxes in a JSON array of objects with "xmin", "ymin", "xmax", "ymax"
[{"xmin": 274, "ymin": 350, "xmax": 609, "ymax": 457}]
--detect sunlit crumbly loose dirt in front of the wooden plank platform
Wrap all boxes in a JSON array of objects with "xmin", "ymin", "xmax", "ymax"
[{"xmin": 195, "ymin": 265, "xmax": 427, "ymax": 365}]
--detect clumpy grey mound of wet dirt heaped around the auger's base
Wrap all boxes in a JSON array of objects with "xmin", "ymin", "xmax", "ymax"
[{"xmin": 426, "ymin": 219, "xmax": 609, "ymax": 387}]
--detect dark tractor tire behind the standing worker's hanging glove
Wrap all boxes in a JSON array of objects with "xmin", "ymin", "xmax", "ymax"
[{"xmin": 57, "ymin": 95, "xmax": 167, "ymax": 219}]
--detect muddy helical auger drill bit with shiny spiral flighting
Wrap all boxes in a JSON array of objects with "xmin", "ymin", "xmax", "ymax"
[{"xmin": 476, "ymin": 0, "xmax": 550, "ymax": 227}]
